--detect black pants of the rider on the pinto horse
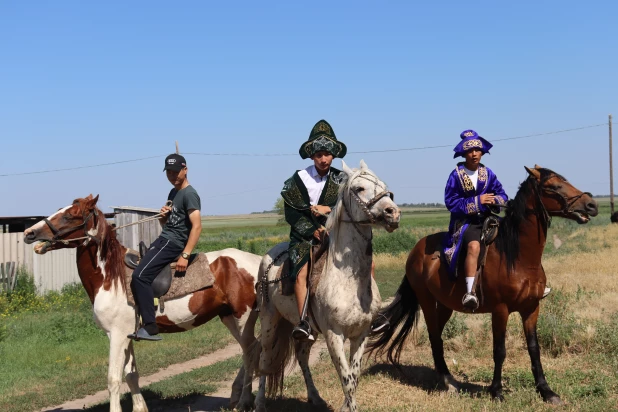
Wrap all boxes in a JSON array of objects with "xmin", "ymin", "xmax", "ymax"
[{"xmin": 131, "ymin": 237, "xmax": 184, "ymax": 325}]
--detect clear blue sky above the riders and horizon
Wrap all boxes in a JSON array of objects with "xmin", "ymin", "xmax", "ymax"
[{"xmin": 0, "ymin": 1, "xmax": 618, "ymax": 216}]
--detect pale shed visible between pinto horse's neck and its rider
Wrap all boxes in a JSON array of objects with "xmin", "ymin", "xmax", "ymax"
[{"xmin": 112, "ymin": 206, "xmax": 162, "ymax": 250}]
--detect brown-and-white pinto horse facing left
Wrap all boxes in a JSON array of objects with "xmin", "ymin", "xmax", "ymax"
[{"xmin": 24, "ymin": 195, "xmax": 261, "ymax": 412}]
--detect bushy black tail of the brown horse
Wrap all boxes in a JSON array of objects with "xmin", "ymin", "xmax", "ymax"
[{"xmin": 367, "ymin": 276, "xmax": 419, "ymax": 367}]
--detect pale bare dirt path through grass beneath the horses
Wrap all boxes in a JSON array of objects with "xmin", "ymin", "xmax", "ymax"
[{"xmin": 41, "ymin": 339, "xmax": 326, "ymax": 412}]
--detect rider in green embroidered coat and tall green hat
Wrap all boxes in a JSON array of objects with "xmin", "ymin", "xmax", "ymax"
[{"xmin": 281, "ymin": 120, "xmax": 347, "ymax": 339}]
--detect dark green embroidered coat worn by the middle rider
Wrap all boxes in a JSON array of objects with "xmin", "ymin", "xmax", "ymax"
[{"xmin": 281, "ymin": 167, "xmax": 346, "ymax": 278}]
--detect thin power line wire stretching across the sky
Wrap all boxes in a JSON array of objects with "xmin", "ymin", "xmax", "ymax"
[{"xmin": 0, "ymin": 123, "xmax": 608, "ymax": 177}]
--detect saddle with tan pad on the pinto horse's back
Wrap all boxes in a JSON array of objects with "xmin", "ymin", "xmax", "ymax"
[{"xmin": 124, "ymin": 241, "xmax": 214, "ymax": 312}]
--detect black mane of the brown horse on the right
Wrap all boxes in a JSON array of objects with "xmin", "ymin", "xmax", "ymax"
[{"xmin": 496, "ymin": 168, "xmax": 566, "ymax": 274}]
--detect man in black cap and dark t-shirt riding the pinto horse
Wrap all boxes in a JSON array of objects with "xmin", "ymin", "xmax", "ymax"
[{"xmin": 129, "ymin": 154, "xmax": 202, "ymax": 341}]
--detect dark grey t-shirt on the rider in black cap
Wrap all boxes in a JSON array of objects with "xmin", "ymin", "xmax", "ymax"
[{"xmin": 161, "ymin": 185, "xmax": 202, "ymax": 248}]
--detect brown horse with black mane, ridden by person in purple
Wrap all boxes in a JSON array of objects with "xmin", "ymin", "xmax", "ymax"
[{"xmin": 368, "ymin": 166, "xmax": 598, "ymax": 404}]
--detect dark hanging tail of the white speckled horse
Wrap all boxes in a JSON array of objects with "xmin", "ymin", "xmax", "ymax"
[{"xmin": 258, "ymin": 316, "xmax": 295, "ymax": 397}]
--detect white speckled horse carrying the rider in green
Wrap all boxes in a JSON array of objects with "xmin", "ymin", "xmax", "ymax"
[{"xmin": 248, "ymin": 161, "xmax": 400, "ymax": 411}]
